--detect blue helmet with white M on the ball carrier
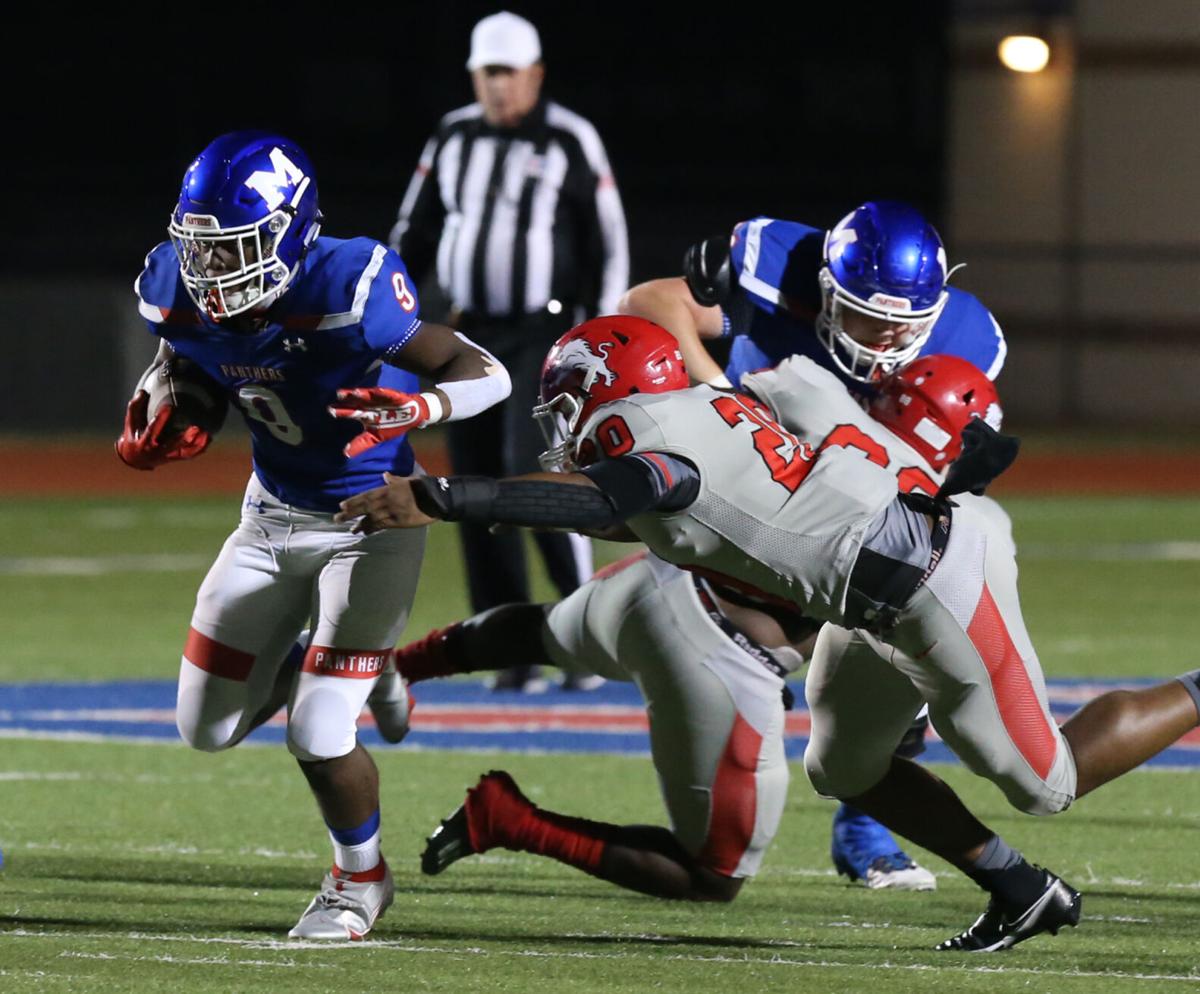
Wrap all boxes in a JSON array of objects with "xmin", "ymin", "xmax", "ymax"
[{"xmin": 167, "ymin": 131, "xmax": 322, "ymax": 321}]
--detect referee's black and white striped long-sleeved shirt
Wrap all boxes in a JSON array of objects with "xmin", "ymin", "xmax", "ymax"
[{"xmin": 389, "ymin": 101, "xmax": 629, "ymax": 317}]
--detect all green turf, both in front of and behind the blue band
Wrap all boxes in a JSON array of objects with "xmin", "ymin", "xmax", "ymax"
[{"xmin": 0, "ymin": 497, "xmax": 1200, "ymax": 994}]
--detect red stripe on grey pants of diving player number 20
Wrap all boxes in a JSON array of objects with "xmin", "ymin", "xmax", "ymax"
[{"xmin": 967, "ymin": 585, "xmax": 1057, "ymax": 780}]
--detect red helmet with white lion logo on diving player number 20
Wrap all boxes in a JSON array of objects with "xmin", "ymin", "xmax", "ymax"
[{"xmin": 533, "ymin": 315, "xmax": 688, "ymax": 472}]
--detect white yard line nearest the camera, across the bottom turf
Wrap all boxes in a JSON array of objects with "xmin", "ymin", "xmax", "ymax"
[{"xmin": 0, "ymin": 928, "xmax": 1200, "ymax": 984}]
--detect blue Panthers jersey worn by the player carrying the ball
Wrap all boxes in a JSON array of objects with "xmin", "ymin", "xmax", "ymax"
[{"xmin": 134, "ymin": 238, "xmax": 421, "ymax": 511}]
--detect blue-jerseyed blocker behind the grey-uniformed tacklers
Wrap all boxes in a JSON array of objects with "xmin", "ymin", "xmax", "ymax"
[{"xmin": 620, "ymin": 200, "xmax": 1007, "ymax": 890}]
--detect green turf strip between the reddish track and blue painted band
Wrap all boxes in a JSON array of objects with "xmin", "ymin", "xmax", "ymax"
[{"xmin": 0, "ymin": 497, "xmax": 1200, "ymax": 683}]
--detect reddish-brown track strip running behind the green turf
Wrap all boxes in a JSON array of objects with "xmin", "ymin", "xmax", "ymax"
[{"xmin": 0, "ymin": 431, "xmax": 1200, "ymax": 498}]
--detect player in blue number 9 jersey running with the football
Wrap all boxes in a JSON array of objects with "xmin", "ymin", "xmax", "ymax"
[{"xmin": 116, "ymin": 131, "xmax": 510, "ymax": 940}]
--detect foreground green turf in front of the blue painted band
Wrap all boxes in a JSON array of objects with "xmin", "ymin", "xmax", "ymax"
[{"xmin": 0, "ymin": 741, "xmax": 1200, "ymax": 994}]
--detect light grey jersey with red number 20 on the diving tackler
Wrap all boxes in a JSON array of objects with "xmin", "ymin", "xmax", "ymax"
[{"xmin": 582, "ymin": 385, "xmax": 898, "ymax": 621}]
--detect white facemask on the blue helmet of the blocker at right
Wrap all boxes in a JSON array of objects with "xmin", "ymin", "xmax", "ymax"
[{"xmin": 816, "ymin": 267, "xmax": 949, "ymax": 383}]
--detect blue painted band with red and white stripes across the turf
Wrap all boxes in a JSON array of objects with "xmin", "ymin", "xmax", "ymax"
[{"xmin": 0, "ymin": 679, "xmax": 1200, "ymax": 768}]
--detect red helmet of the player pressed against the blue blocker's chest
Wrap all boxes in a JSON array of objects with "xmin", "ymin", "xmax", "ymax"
[{"xmin": 870, "ymin": 355, "xmax": 1002, "ymax": 469}]
